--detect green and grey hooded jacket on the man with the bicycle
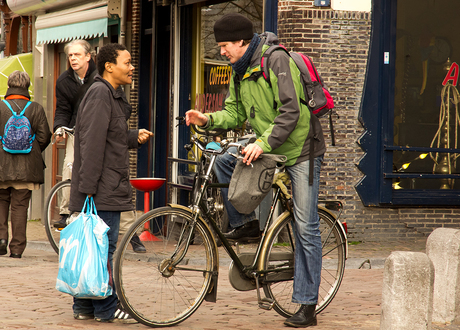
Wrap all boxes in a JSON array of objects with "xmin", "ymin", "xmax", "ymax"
[{"xmin": 206, "ymin": 32, "xmax": 326, "ymax": 166}]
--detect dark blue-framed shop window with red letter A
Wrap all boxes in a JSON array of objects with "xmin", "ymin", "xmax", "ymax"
[{"xmin": 357, "ymin": 0, "xmax": 460, "ymax": 206}]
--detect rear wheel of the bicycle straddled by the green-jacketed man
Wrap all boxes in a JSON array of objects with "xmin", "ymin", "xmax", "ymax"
[{"xmin": 263, "ymin": 209, "xmax": 346, "ymax": 317}]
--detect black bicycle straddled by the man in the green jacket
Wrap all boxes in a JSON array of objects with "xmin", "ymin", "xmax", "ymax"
[{"xmin": 114, "ymin": 130, "xmax": 347, "ymax": 327}]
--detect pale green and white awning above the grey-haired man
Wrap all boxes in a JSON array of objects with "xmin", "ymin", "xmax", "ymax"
[{"xmin": 35, "ymin": 1, "xmax": 110, "ymax": 44}]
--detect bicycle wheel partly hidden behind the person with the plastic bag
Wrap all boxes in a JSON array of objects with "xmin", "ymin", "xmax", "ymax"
[{"xmin": 44, "ymin": 180, "xmax": 71, "ymax": 253}]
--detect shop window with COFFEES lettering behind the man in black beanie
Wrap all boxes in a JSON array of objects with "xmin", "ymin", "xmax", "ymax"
[{"xmin": 172, "ymin": 0, "xmax": 266, "ymax": 204}]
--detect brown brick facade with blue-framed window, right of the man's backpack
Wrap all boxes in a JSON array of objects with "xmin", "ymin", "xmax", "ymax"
[{"xmin": 278, "ymin": 0, "xmax": 460, "ymax": 241}]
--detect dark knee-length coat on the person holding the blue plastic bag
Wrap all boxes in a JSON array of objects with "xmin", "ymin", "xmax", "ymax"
[{"xmin": 69, "ymin": 75, "xmax": 140, "ymax": 212}]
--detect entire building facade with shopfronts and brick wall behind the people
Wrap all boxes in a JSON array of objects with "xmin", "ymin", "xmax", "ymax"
[{"xmin": 7, "ymin": 0, "xmax": 460, "ymax": 241}]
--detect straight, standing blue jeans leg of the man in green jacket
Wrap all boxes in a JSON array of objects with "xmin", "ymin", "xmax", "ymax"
[{"xmin": 286, "ymin": 156, "xmax": 323, "ymax": 305}]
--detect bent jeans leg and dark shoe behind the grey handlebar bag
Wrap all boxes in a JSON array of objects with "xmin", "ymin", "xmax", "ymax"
[{"xmin": 213, "ymin": 140, "xmax": 256, "ymax": 228}]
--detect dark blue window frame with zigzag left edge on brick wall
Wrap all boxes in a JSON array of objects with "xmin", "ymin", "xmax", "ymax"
[{"xmin": 355, "ymin": 0, "xmax": 460, "ymax": 207}]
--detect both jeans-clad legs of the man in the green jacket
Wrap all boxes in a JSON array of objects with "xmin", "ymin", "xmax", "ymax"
[{"xmin": 214, "ymin": 147, "xmax": 323, "ymax": 305}]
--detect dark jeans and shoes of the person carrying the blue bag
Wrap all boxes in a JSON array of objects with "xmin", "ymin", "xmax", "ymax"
[{"xmin": 73, "ymin": 211, "xmax": 120, "ymax": 320}]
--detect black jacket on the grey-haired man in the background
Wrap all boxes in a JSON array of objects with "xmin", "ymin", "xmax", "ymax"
[{"xmin": 53, "ymin": 59, "xmax": 96, "ymax": 132}]
